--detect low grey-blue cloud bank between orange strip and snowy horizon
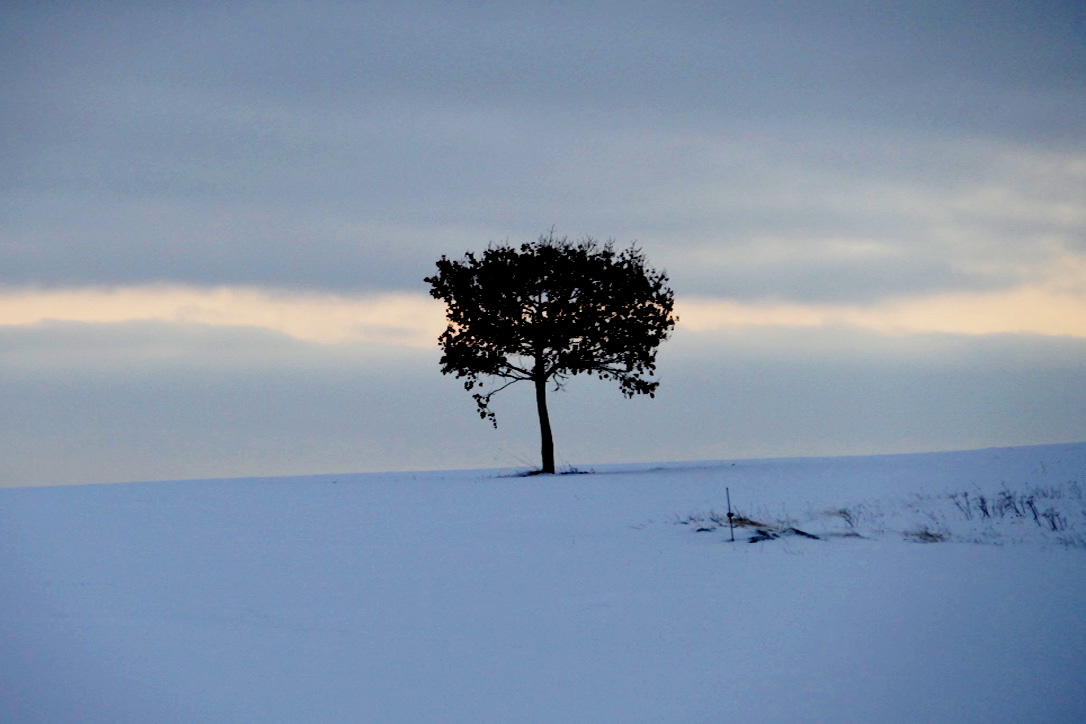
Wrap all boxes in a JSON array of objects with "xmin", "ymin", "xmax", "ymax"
[{"xmin": 0, "ymin": 323, "xmax": 1086, "ymax": 485}]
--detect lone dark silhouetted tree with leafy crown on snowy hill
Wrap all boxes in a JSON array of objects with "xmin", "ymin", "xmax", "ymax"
[{"xmin": 425, "ymin": 230, "xmax": 678, "ymax": 473}]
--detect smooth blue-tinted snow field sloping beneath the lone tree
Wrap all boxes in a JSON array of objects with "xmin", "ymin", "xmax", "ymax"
[{"xmin": 0, "ymin": 443, "xmax": 1086, "ymax": 723}]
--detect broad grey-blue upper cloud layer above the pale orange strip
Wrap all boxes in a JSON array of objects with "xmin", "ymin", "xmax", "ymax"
[{"xmin": 0, "ymin": 3, "xmax": 1086, "ymax": 301}]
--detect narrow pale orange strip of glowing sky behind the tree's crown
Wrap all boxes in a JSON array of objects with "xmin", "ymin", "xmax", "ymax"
[{"xmin": 0, "ymin": 285, "xmax": 1086, "ymax": 348}]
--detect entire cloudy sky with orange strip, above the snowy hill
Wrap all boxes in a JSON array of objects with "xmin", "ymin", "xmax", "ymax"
[{"xmin": 0, "ymin": 0, "xmax": 1086, "ymax": 485}]
